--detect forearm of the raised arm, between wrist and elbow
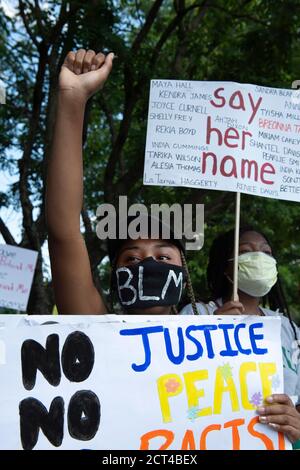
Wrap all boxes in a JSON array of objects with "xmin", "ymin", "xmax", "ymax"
[{"xmin": 46, "ymin": 90, "xmax": 85, "ymax": 240}]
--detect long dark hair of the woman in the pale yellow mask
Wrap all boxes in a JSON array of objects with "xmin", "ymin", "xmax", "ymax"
[{"xmin": 206, "ymin": 226, "xmax": 298, "ymax": 340}]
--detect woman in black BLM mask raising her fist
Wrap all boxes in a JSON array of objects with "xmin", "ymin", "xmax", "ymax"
[{"xmin": 46, "ymin": 49, "xmax": 196, "ymax": 315}]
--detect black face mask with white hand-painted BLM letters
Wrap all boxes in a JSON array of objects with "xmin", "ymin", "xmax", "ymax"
[{"xmin": 113, "ymin": 257, "xmax": 186, "ymax": 310}]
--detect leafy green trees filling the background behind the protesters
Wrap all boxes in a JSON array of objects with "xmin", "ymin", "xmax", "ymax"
[{"xmin": 0, "ymin": 0, "xmax": 300, "ymax": 316}]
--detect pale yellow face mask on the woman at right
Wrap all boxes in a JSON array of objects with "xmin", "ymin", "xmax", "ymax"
[{"xmin": 234, "ymin": 251, "xmax": 277, "ymax": 297}]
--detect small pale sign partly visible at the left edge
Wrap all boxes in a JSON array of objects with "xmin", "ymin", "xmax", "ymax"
[{"xmin": 0, "ymin": 244, "xmax": 38, "ymax": 311}]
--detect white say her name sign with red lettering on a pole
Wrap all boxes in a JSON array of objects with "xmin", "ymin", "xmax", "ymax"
[{"xmin": 144, "ymin": 80, "xmax": 300, "ymax": 201}]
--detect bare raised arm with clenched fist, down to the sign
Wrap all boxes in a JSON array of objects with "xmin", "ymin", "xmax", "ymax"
[{"xmin": 46, "ymin": 49, "xmax": 113, "ymax": 314}]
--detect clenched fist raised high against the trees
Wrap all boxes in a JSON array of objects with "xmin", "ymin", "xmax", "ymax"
[{"xmin": 59, "ymin": 49, "xmax": 114, "ymax": 100}]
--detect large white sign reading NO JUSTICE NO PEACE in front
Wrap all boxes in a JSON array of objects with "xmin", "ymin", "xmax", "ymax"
[{"xmin": 0, "ymin": 315, "xmax": 290, "ymax": 450}]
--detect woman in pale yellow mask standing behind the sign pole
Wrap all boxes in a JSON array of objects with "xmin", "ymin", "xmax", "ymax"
[{"xmin": 181, "ymin": 227, "xmax": 300, "ymax": 443}]
